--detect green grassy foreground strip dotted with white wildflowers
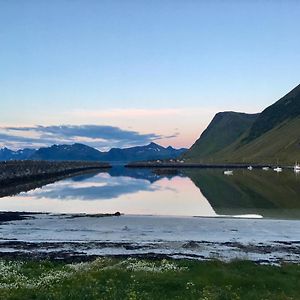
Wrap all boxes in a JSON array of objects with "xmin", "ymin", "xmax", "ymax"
[{"xmin": 0, "ymin": 258, "xmax": 300, "ymax": 300}]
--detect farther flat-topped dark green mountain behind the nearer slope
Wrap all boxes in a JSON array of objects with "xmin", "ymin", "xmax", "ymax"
[{"xmin": 184, "ymin": 112, "xmax": 258, "ymax": 160}]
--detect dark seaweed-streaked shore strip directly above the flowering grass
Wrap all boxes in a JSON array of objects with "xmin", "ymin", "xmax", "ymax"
[{"xmin": 0, "ymin": 241, "xmax": 300, "ymax": 264}]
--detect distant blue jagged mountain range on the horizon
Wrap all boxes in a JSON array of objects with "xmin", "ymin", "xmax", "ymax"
[{"xmin": 0, "ymin": 143, "xmax": 187, "ymax": 162}]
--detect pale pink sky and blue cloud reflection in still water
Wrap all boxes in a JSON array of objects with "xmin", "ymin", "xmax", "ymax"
[{"xmin": 0, "ymin": 173, "xmax": 215, "ymax": 216}]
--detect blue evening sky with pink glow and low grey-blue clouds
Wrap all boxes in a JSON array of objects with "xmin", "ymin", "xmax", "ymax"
[{"xmin": 0, "ymin": 0, "xmax": 300, "ymax": 150}]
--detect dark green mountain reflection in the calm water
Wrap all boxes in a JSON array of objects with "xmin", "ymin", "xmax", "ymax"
[{"xmin": 184, "ymin": 170, "xmax": 300, "ymax": 219}]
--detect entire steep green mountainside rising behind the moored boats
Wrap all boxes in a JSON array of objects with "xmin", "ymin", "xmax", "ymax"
[{"xmin": 183, "ymin": 85, "xmax": 300, "ymax": 164}]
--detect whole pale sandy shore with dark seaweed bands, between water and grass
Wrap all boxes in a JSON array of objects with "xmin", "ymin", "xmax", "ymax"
[{"xmin": 0, "ymin": 214, "xmax": 300, "ymax": 264}]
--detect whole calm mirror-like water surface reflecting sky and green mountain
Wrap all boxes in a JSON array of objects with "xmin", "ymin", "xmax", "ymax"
[{"xmin": 0, "ymin": 167, "xmax": 300, "ymax": 219}]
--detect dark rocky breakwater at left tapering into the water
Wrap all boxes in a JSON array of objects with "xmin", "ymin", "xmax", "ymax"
[{"xmin": 0, "ymin": 161, "xmax": 110, "ymax": 185}]
